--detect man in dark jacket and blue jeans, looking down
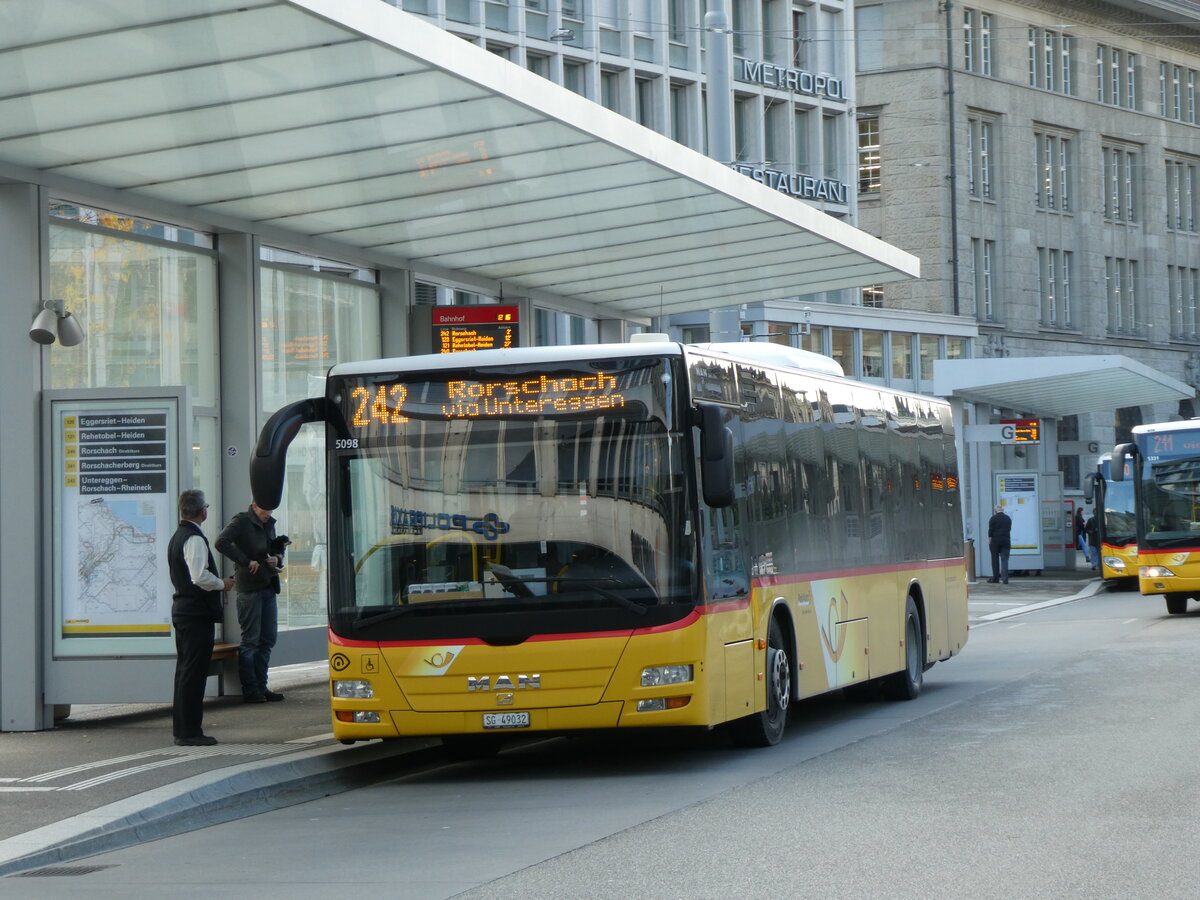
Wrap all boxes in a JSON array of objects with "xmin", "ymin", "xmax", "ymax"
[{"xmin": 216, "ymin": 503, "xmax": 289, "ymax": 703}]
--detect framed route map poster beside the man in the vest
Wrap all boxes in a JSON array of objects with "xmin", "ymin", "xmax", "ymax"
[{"xmin": 48, "ymin": 391, "xmax": 184, "ymax": 656}]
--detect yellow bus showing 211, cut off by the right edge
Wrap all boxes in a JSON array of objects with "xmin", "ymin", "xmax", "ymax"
[{"xmin": 1111, "ymin": 419, "xmax": 1200, "ymax": 616}]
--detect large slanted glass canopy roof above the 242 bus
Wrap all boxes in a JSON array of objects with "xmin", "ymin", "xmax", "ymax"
[{"xmin": 0, "ymin": 0, "xmax": 918, "ymax": 318}]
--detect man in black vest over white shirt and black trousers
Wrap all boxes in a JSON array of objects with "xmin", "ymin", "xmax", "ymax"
[{"xmin": 167, "ymin": 490, "xmax": 233, "ymax": 746}]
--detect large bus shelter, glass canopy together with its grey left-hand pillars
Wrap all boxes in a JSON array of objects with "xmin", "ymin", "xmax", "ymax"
[{"xmin": 0, "ymin": 0, "xmax": 919, "ymax": 731}]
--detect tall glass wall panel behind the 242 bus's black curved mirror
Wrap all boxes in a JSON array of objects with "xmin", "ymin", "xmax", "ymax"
[{"xmin": 259, "ymin": 265, "xmax": 380, "ymax": 628}]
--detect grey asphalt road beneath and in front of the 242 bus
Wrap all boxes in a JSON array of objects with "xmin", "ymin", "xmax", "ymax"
[{"xmin": 14, "ymin": 594, "xmax": 1200, "ymax": 900}]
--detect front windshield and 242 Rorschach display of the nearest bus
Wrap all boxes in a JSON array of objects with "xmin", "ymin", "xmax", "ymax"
[{"xmin": 330, "ymin": 358, "xmax": 696, "ymax": 642}]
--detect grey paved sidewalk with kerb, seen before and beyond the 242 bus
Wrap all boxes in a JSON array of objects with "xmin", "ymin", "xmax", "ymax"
[{"xmin": 0, "ymin": 571, "xmax": 1105, "ymax": 876}]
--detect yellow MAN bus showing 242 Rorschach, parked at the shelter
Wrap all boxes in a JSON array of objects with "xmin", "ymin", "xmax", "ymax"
[{"xmin": 251, "ymin": 340, "xmax": 967, "ymax": 748}]
